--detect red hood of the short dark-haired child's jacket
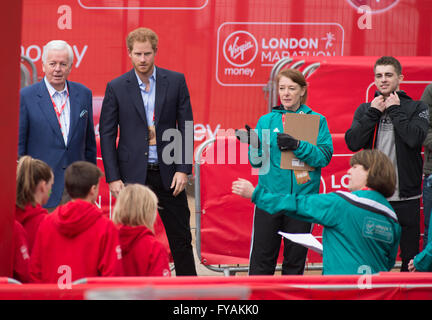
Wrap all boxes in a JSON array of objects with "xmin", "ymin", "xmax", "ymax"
[{"xmin": 52, "ymin": 199, "xmax": 102, "ymax": 238}]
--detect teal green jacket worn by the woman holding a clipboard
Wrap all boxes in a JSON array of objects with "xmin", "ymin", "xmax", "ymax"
[{"xmin": 249, "ymin": 105, "xmax": 333, "ymax": 195}]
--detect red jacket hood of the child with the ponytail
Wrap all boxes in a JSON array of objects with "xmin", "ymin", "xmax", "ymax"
[{"xmin": 15, "ymin": 203, "xmax": 48, "ymax": 254}]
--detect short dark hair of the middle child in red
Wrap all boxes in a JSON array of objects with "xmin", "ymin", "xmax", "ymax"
[{"xmin": 65, "ymin": 161, "xmax": 103, "ymax": 199}]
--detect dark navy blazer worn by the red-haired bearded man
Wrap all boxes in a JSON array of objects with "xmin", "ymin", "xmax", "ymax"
[{"xmin": 99, "ymin": 67, "xmax": 193, "ymax": 190}]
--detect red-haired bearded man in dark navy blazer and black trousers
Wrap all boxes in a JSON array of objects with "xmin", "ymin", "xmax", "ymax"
[{"xmin": 99, "ymin": 28, "xmax": 196, "ymax": 275}]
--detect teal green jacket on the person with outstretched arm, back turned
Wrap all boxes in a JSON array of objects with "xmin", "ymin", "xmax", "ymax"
[{"xmin": 252, "ymin": 185, "xmax": 401, "ymax": 275}]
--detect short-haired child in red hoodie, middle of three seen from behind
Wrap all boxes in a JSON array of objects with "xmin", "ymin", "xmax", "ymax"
[{"xmin": 30, "ymin": 161, "xmax": 123, "ymax": 288}]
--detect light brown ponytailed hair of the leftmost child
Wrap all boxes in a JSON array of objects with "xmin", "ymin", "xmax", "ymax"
[{"xmin": 15, "ymin": 156, "xmax": 54, "ymax": 209}]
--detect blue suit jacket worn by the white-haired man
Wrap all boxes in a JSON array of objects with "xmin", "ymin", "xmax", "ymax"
[{"xmin": 18, "ymin": 80, "xmax": 96, "ymax": 208}]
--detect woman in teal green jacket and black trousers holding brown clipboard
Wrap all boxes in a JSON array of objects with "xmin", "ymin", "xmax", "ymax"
[{"xmin": 237, "ymin": 69, "xmax": 333, "ymax": 275}]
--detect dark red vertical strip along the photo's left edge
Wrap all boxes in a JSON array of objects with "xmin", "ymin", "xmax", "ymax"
[{"xmin": 0, "ymin": 0, "xmax": 22, "ymax": 276}]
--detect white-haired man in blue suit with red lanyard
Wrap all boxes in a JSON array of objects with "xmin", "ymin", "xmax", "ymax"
[{"xmin": 18, "ymin": 40, "xmax": 96, "ymax": 209}]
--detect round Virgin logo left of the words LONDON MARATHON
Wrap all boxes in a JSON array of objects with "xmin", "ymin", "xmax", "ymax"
[{"xmin": 223, "ymin": 31, "xmax": 258, "ymax": 67}]
